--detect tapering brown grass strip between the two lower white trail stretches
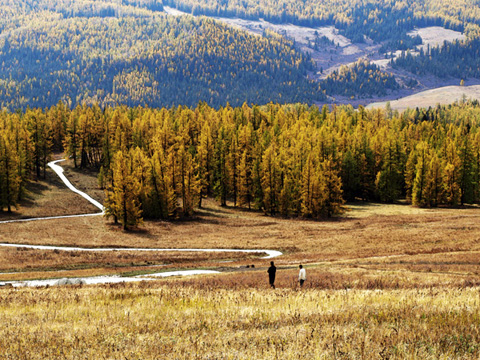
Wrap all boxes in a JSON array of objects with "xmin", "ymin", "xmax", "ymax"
[{"xmin": 0, "ymin": 248, "xmax": 259, "ymax": 280}]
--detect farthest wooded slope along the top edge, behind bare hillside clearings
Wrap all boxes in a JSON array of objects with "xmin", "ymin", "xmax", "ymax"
[{"xmin": 164, "ymin": 0, "xmax": 480, "ymax": 44}]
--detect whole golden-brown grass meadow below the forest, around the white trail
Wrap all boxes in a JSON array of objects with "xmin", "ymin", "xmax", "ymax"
[{"xmin": 0, "ymin": 160, "xmax": 480, "ymax": 359}]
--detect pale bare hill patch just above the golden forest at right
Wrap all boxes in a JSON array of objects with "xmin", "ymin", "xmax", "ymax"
[{"xmin": 367, "ymin": 85, "xmax": 480, "ymax": 111}]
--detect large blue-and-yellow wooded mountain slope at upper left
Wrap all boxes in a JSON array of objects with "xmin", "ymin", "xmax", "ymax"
[{"xmin": 0, "ymin": 0, "xmax": 324, "ymax": 109}]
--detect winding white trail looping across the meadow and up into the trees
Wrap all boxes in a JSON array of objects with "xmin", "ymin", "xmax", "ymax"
[{"xmin": 0, "ymin": 160, "xmax": 283, "ymax": 287}]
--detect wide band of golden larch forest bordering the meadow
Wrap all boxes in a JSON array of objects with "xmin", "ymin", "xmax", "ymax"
[{"xmin": 0, "ymin": 102, "xmax": 480, "ymax": 227}]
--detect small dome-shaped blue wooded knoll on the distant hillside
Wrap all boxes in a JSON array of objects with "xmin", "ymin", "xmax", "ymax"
[{"xmin": 321, "ymin": 59, "xmax": 400, "ymax": 99}]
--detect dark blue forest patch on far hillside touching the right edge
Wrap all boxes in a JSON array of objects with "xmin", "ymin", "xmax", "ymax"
[{"xmin": 392, "ymin": 38, "xmax": 480, "ymax": 79}]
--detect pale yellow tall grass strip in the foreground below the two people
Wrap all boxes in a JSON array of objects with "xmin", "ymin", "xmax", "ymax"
[{"xmin": 0, "ymin": 280, "xmax": 480, "ymax": 359}]
